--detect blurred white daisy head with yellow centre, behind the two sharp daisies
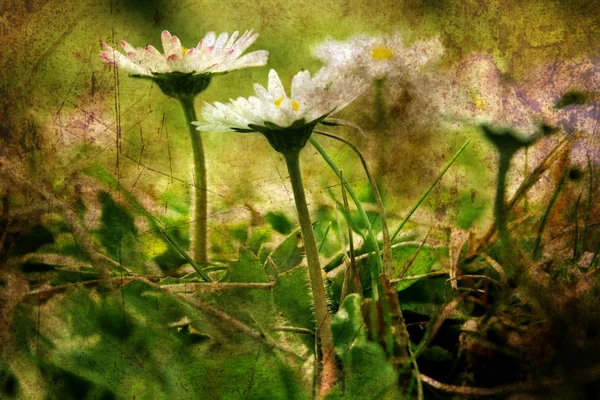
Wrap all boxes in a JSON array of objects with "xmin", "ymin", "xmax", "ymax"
[{"xmin": 313, "ymin": 33, "xmax": 444, "ymax": 79}]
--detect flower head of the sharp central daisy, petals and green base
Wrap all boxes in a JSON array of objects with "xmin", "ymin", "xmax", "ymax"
[{"xmin": 194, "ymin": 69, "xmax": 366, "ymax": 152}]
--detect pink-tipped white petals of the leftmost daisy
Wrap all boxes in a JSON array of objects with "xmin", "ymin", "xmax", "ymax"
[{"xmin": 100, "ymin": 31, "xmax": 269, "ymax": 78}]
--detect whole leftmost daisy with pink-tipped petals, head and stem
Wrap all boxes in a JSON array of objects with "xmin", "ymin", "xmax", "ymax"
[{"xmin": 100, "ymin": 31, "xmax": 269, "ymax": 268}]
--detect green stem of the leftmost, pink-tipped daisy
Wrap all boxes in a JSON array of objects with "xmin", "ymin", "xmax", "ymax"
[{"xmin": 179, "ymin": 96, "xmax": 208, "ymax": 265}]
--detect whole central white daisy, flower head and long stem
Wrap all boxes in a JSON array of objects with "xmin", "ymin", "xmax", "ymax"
[{"xmin": 195, "ymin": 69, "xmax": 366, "ymax": 397}]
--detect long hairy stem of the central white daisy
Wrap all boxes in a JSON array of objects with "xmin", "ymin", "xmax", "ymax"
[{"xmin": 284, "ymin": 151, "xmax": 335, "ymax": 395}]
